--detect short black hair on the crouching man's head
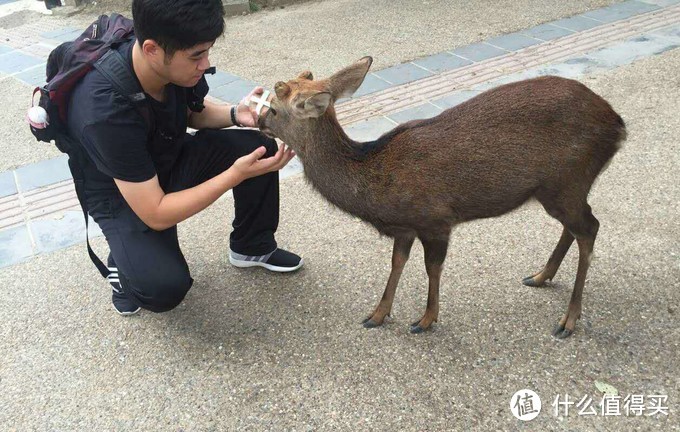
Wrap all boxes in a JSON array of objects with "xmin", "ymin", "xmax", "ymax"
[{"xmin": 132, "ymin": 0, "xmax": 224, "ymax": 57}]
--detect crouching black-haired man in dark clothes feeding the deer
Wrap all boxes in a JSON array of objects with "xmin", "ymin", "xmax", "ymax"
[{"xmin": 68, "ymin": 0, "xmax": 303, "ymax": 315}]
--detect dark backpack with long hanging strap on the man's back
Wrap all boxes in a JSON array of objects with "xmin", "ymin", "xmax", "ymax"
[{"xmin": 29, "ymin": 14, "xmax": 153, "ymax": 277}]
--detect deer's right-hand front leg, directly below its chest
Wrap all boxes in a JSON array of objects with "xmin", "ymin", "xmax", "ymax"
[{"xmin": 411, "ymin": 238, "xmax": 449, "ymax": 333}]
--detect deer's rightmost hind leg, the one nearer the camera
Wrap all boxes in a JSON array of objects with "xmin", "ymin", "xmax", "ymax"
[{"xmin": 553, "ymin": 204, "xmax": 600, "ymax": 339}]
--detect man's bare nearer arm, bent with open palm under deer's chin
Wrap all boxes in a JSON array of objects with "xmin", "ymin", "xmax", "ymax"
[{"xmin": 114, "ymin": 144, "xmax": 295, "ymax": 231}]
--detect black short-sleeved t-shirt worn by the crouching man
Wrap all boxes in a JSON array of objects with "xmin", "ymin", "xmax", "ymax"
[{"xmin": 68, "ymin": 40, "xmax": 208, "ymax": 198}]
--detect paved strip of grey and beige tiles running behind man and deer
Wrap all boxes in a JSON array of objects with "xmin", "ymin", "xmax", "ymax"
[{"xmin": 0, "ymin": 0, "xmax": 680, "ymax": 267}]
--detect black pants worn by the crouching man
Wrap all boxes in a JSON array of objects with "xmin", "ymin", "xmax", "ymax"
[{"xmin": 88, "ymin": 130, "xmax": 279, "ymax": 312}]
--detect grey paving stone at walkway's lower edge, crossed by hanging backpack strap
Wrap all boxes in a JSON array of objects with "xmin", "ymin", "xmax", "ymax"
[{"xmin": 31, "ymin": 211, "xmax": 102, "ymax": 253}]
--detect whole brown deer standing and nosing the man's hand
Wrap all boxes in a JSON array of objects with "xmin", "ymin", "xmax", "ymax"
[{"xmin": 258, "ymin": 57, "xmax": 626, "ymax": 339}]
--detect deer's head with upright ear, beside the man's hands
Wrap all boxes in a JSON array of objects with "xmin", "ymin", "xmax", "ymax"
[{"xmin": 259, "ymin": 57, "xmax": 373, "ymax": 155}]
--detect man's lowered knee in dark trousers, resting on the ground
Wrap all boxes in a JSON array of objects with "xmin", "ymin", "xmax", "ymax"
[{"xmin": 128, "ymin": 271, "xmax": 194, "ymax": 312}]
